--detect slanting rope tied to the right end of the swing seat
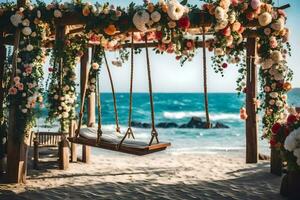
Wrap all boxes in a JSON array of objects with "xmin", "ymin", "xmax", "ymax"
[{"xmin": 145, "ymin": 33, "xmax": 159, "ymax": 146}]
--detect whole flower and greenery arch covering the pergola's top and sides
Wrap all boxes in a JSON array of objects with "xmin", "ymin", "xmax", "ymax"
[{"xmin": 0, "ymin": 0, "xmax": 292, "ymax": 181}]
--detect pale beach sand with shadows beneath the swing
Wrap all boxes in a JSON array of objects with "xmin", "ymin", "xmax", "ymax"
[{"xmin": 0, "ymin": 150, "xmax": 282, "ymax": 200}]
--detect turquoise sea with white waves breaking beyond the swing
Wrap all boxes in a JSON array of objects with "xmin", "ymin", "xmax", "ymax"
[{"xmin": 39, "ymin": 90, "xmax": 300, "ymax": 154}]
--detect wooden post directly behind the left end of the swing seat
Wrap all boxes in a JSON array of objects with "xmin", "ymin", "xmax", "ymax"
[{"xmin": 80, "ymin": 49, "xmax": 95, "ymax": 163}]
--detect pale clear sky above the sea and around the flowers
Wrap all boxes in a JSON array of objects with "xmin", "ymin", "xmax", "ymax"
[{"xmin": 0, "ymin": 0, "xmax": 300, "ymax": 92}]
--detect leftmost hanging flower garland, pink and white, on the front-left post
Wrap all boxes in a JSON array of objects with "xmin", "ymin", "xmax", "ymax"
[{"xmin": 8, "ymin": 7, "xmax": 46, "ymax": 139}]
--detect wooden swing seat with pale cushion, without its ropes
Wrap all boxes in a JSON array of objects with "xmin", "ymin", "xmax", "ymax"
[{"xmin": 68, "ymin": 127, "xmax": 171, "ymax": 156}]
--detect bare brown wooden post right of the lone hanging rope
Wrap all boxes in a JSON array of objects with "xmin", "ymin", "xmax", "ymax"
[{"xmin": 246, "ymin": 37, "xmax": 258, "ymax": 163}]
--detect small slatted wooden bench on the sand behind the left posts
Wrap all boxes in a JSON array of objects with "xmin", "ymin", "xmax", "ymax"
[{"xmin": 33, "ymin": 132, "xmax": 61, "ymax": 169}]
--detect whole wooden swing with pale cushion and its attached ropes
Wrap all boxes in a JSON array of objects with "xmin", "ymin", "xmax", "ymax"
[{"xmin": 69, "ymin": 33, "xmax": 171, "ymax": 155}]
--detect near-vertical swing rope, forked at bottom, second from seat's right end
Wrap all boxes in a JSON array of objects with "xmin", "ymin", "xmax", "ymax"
[{"xmin": 117, "ymin": 33, "xmax": 135, "ymax": 149}]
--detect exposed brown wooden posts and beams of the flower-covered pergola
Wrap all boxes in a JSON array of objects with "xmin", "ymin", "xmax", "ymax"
[{"xmin": 0, "ymin": 0, "xmax": 289, "ymax": 183}]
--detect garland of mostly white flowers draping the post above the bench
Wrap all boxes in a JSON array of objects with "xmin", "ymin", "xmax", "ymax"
[{"xmin": 47, "ymin": 35, "xmax": 87, "ymax": 130}]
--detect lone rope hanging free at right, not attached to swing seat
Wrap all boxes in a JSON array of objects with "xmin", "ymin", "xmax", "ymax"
[{"xmin": 202, "ymin": 26, "xmax": 211, "ymax": 128}]
